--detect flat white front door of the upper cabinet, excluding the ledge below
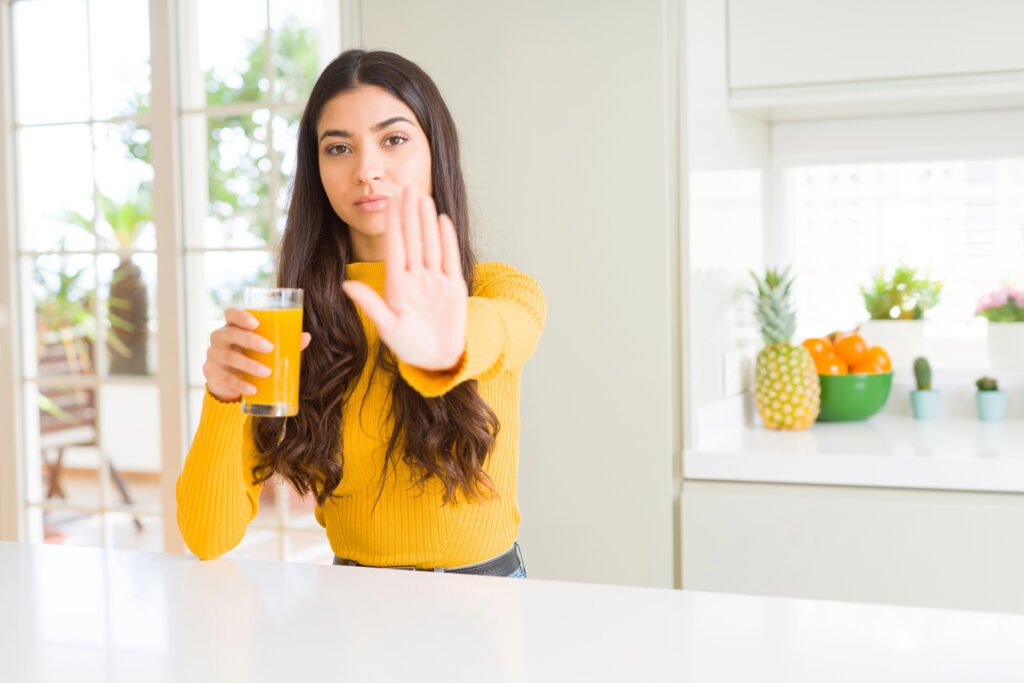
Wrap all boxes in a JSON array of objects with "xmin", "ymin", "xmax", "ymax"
[{"xmin": 729, "ymin": 0, "xmax": 1024, "ymax": 88}]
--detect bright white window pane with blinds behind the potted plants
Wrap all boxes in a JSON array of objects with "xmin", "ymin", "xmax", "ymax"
[{"xmin": 783, "ymin": 157, "xmax": 1024, "ymax": 337}]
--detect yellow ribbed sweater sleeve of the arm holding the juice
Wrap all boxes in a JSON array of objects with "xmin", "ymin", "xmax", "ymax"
[{"xmin": 175, "ymin": 389, "xmax": 263, "ymax": 560}]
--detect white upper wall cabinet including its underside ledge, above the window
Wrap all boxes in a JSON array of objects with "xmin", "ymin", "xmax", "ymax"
[{"xmin": 727, "ymin": 0, "xmax": 1024, "ymax": 118}]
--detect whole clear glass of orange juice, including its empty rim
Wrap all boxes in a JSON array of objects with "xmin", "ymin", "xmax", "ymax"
[{"xmin": 242, "ymin": 287, "xmax": 302, "ymax": 418}]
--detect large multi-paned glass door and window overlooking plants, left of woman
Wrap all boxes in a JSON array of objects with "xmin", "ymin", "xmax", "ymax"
[{"xmin": 0, "ymin": 0, "xmax": 357, "ymax": 562}]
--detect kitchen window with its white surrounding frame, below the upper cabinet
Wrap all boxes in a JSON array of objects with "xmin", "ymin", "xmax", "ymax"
[{"xmin": 766, "ymin": 111, "xmax": 1024, "ymax": 371}]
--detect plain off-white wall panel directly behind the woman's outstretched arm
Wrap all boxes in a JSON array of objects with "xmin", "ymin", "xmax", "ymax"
[{"xmin": 361, "ymin": 0, "xmax": 680, "ymax": 587}]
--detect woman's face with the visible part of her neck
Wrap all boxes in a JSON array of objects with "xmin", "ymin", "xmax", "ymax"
[{"xmin": 316, "ymin": 85, "xmax": 433, "ymax": 261}]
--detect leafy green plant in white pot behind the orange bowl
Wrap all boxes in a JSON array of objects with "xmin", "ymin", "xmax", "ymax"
[{"xmin": 860, "ymin": 262, "xmax": 942, "ymax": 366}]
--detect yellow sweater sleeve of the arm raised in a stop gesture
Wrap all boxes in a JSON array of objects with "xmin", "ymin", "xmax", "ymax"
[{"xmin": 398, "ymin": 263, "xmax": 547, "ymax": 397}]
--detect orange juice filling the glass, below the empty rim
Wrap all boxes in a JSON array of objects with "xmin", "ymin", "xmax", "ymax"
[{"xmin": 242, "ymin": 308, "xmax": 302, "ymax": 417}]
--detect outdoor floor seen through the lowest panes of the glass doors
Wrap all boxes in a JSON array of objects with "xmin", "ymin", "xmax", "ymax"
[{"xmin": 43, "ymin": 472, "xmax": 334, "ymax": 564}]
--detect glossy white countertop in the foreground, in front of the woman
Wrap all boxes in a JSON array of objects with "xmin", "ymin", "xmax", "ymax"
[{"xmin": 0, "ymin": 543, "xmax": 1024, "ymax": 683}]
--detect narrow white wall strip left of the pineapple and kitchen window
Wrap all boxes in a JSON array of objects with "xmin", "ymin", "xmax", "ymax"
[{"xmin": 683, "ymin": 0, "xmax": 771, "ymax": 445}]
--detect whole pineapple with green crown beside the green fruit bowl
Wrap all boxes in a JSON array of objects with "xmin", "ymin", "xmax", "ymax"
[{"xmin": 751, "ymin": 268, "xmax": 821, "ymax": 429}]
